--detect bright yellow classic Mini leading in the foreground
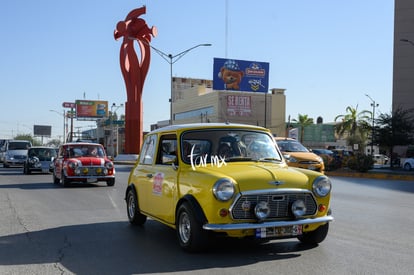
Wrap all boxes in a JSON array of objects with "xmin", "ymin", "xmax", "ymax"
[{"xmin": 125, "ymin": 123, "xmax": 333, "ymax": 251}]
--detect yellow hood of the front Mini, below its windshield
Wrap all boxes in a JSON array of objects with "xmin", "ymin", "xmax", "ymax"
[{"xmin": 193, "ymin": 162, "xmax": 314, "ymax": 191}]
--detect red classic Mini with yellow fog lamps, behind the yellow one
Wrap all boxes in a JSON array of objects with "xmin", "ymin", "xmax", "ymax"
[{"xmin": 53, "ymin": 142, "xmax": 115, "ymax": 186}]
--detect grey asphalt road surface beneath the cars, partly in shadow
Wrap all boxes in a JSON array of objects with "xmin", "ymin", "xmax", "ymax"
[{"xmin": 0, "ymin": 166, "xmax": 414, "ymax": 275}]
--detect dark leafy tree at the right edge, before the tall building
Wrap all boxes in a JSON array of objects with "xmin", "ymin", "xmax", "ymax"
[{"xmin": 374, "ymin": 107, "xmax": 414, "ymax": 168}]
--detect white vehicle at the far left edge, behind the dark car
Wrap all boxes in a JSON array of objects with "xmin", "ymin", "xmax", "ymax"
[{"xmin": 3, "ymin": 140, "xmax": 32, "ymax": 168}]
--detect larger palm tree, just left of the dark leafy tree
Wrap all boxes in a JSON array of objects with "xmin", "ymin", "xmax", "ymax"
[{"xmin": 335, "ymin": 105, "xmax": 372, "ymax": 150}]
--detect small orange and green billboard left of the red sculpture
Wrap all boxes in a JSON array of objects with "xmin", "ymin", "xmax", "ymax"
[{"xmin": 75, "ymin": 100, "xmax": 108, "ymax": 119}]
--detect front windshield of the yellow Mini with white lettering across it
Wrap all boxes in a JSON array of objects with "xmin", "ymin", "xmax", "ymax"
[{"xmin": 181, "ymin": 129, "xmax": 282, "ymax": 163}]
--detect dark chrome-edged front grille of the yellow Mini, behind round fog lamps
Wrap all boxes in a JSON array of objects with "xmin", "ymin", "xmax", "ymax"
[{"xmin": 230, "ymin": 191, "xmax": 317, "ymax": 220}]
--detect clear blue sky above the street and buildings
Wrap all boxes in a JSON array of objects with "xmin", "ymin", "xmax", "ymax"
[{"xmin": 0, "ymin": 0, "xmax": 394, "ymax": 141}]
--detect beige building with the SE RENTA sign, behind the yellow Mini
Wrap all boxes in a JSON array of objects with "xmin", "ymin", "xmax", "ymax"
[{"xmin": 163, "ymin": 77, "xmax": 286, "ymax": 136}]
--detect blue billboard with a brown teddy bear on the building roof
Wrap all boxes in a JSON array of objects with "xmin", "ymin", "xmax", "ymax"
[{"xmin": 213, "ymin": 58, "xmax": 269, "ymax": 93}]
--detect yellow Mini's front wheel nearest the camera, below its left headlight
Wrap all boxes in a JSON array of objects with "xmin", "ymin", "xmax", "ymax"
[{"xmin": 176, "ymin": 202, "xmax": 208, "ymax": 252}]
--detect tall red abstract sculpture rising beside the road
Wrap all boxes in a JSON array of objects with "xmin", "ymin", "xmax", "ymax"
[{"xmin": 114, "ymin": 6, "xmax": 157, "ymax": 154}]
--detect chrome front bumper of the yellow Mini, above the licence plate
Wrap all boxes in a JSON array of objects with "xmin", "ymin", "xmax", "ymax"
[{"xmin": 203, "ymin": 216, "xmax": 334, "ymax": 231}]
